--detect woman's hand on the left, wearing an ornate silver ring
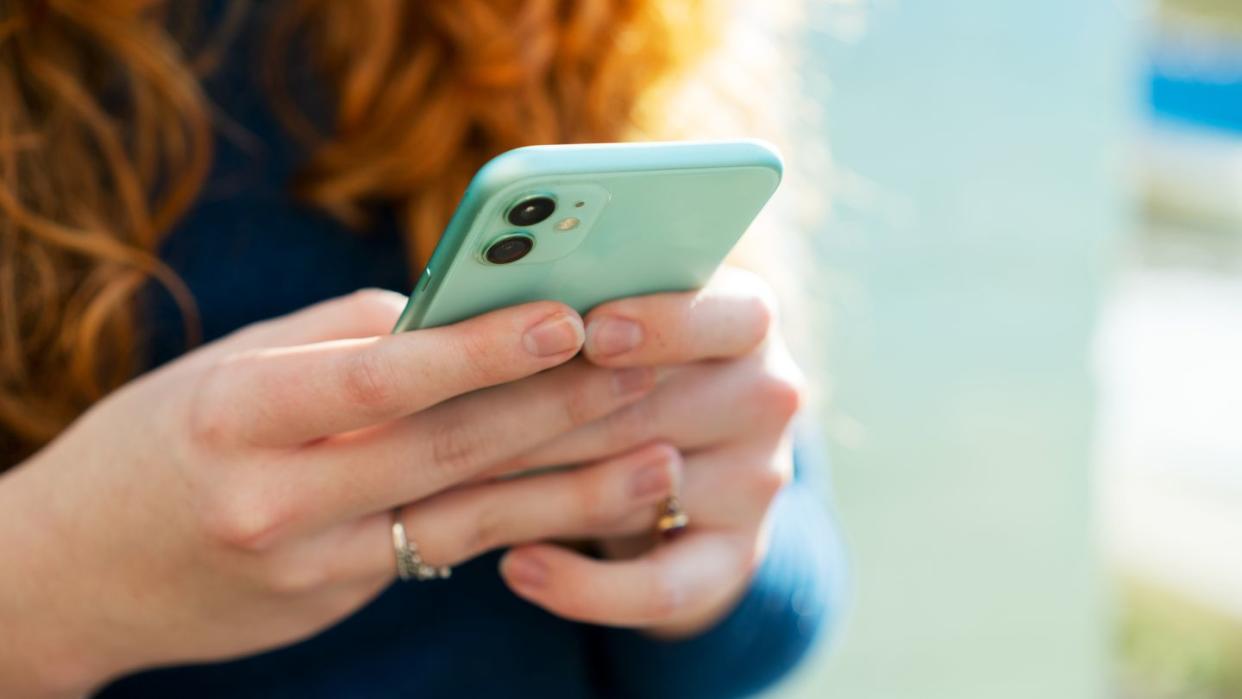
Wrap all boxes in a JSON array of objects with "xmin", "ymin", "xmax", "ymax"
[{"xmin": 0, "ymin": 286, "xmax": 679, "ymax": 697}]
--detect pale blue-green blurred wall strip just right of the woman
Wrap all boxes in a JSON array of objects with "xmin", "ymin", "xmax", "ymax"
[{"xmin": 780, "ymin": 0, "xmax": 1138, "ymax": 699}]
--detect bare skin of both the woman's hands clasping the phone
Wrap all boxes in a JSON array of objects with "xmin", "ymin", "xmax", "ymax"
[{"xmin": 0, "ymin": 269, "xmax": 801, "ymax": 697}]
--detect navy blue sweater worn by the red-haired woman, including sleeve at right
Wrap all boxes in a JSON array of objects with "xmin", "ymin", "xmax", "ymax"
[{"xmin": 99, "ymin": 6, "xmax": 842, "ymax": 699}]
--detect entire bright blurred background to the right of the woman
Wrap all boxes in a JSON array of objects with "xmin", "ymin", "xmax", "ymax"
[{"xmin": 775, "ymin": 0, "xmax": 1242, "ymax": 699}]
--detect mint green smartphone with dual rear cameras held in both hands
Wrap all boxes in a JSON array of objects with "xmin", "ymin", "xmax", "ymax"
[{"xmin": 394, "ymin": 140, "xmax": 781, "ymax": 331}]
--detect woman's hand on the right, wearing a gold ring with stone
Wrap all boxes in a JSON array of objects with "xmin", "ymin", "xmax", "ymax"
[{"xmin": 501, "ymin": 268, "xmax": 802, "ymax": 638}]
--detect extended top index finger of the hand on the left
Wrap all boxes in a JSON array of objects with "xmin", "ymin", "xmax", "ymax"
[{"xmin": 194, "ymin": 302, "xmax": 584, "ymax": 447}]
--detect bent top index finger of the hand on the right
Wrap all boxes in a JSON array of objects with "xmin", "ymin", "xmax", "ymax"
[{"xmin": 584, "ymin": 268, "xmax": 775, "ymax": 368}]
